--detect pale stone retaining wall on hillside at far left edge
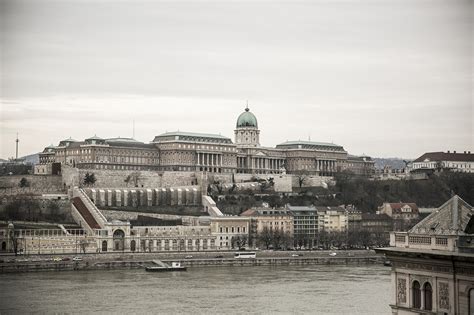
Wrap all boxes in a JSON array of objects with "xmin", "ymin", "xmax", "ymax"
[{"xmin": 0, "ymin": 175, "xmax": 65, "ymax": 196}]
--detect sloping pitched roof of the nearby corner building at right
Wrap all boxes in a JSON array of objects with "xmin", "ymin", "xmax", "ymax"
[{"xmin": 409, "ymin": 195, "xmax": 474, "ymax": 235}]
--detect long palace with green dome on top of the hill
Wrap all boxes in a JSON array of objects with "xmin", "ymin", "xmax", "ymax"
[{"xmin": 35, "ymin": 107, "xmax": 374, "ymax": 176}]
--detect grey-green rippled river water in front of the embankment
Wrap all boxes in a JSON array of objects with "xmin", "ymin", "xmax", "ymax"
[{"xmin": 0, "ymin": 265, "xmax": 391, "ymax": 314}]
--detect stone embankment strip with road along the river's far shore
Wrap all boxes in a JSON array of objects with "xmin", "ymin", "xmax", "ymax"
[{"xmin": 0, "ymin": 251, "xmax": 384, "ymax": 273}]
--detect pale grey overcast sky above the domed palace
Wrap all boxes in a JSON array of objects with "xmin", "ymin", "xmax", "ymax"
[{"xmin": 0, "ymin": 0, "xmax": 474, "ymax": 158}]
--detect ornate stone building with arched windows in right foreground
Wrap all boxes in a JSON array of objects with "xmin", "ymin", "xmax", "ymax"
[{"xmin": 376, "ymin": 196, "xmax": 474, "ymax": 315}]
